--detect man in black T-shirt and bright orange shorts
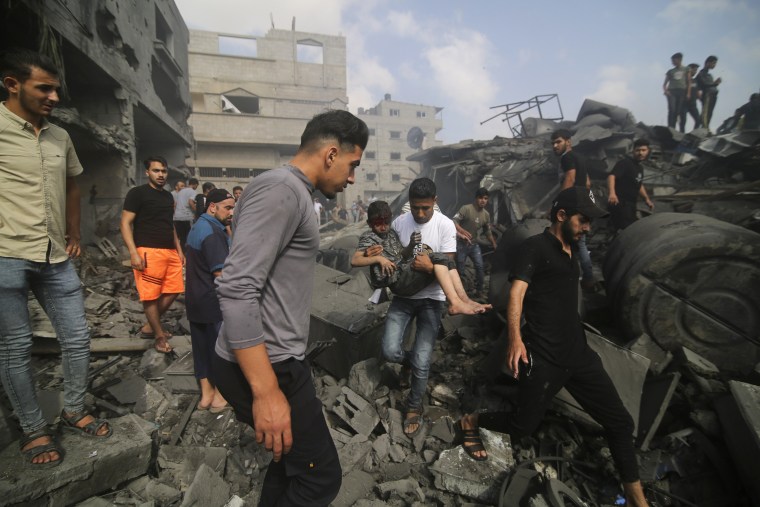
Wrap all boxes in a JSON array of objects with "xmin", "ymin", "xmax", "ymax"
[{"xmin": 121, "ymin": 156, "xmax": 185, "ymax": 353}]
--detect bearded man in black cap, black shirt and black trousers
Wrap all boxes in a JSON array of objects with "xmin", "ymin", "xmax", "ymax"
[{"xmin": 456, "ymin": 187, "xmax": 647, "ymax": 506}]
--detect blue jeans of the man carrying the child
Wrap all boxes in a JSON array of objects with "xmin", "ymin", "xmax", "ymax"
[{"xmin": 383, "ymin": 297, "xmax": 446, "ymax": 410}]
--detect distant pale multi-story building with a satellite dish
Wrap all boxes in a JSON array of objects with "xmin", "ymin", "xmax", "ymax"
[{"xmin": 346, "ymin": 94, "xmax": 443, "ymax": 205}]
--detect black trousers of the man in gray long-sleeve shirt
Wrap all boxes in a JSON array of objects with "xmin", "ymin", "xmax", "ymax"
[{"xmin": 212, "ymin": 354, "xmax": 343, "ymax": 507}]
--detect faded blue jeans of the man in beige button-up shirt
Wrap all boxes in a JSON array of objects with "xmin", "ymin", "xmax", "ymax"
[{"xmin": 0, "ymin": 257, "xmax": 90, "ymax": 433}]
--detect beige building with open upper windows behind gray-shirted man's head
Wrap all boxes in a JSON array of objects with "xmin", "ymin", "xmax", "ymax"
[{"xmin": 187, "ymin": 28, "xmax": 348, "ymax": 195}]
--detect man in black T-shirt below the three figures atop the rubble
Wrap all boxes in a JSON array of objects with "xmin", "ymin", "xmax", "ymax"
[{"xmin": 607, "ymin": 139, "xmax": 654, "ymax": 230}]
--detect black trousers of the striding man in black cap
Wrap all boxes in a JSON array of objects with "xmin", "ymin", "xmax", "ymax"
[{"xmin": 478, "ymin": 345, "xmax": 639, "ymax": 482}]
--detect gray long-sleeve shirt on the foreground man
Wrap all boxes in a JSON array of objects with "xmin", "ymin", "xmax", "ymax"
[{"xmin": 216, "ymin": 166, "xmax": 319, "ymax": 363}]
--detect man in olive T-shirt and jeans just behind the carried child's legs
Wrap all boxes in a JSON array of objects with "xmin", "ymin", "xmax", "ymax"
[{"xmin": 453, "ymin": 188, "xmax": 496, "ymax": 302}]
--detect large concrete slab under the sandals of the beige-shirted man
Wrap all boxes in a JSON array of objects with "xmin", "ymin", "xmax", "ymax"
[{"xmin": 0, "ymin": 415, "xmax": 154, "ymax": 505}]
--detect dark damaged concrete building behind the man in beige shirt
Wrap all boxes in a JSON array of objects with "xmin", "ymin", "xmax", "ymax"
[{"xmin": 0, "ymin": 0, "xmax": 192, "ymax": 243}]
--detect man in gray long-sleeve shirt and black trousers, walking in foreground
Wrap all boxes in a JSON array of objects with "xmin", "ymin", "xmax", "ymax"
[{"xmin": 211, "ymin": 110, "xmax": 369, "ymax": 507}]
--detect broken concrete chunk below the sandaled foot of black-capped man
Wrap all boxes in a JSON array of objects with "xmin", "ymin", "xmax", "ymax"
[{"xmin": 430, "ymin": 428, "xmax": 515, "ymax": 504}]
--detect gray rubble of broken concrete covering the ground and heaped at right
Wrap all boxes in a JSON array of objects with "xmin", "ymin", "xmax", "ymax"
[{"xmin": 0, "ymin": 101, "xmax": 760, "ymax": 507}]
